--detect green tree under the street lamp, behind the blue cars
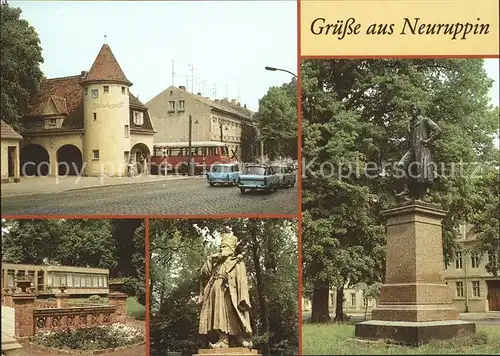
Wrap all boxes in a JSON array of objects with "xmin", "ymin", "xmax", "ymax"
[{"xmin": 255, "ymin": 79, "xmax": 298, "ymax": 158}]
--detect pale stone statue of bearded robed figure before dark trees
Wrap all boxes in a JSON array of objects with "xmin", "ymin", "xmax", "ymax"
[{"xmin": 199, "ymin": 233, "xmax": 252, "ymax": 348}]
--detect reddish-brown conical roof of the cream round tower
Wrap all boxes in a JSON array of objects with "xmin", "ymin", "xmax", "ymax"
[{"xmin": 80, "ymin": 44, "xmax": 132, "ymax": 86}]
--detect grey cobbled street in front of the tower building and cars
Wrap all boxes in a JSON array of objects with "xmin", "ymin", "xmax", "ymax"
[{"xmin": 2, "ymin": 176, "xmax": 298, "ymax": 215}]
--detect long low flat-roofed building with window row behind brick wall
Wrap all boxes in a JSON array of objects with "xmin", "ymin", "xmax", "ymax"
[{"xmin": 2, "ymin": 263, "xmax": 109, "ymax": 296}]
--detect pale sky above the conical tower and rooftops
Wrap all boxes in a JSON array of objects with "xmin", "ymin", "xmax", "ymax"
[{"xmin": 14, "ymin": 0, "xmax": 297, "ymax": 111}]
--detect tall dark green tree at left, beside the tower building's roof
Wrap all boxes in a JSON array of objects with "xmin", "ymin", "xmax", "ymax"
[{"xmin": 0, "ymin": 3, "xmax": 43, "ymax": 130}]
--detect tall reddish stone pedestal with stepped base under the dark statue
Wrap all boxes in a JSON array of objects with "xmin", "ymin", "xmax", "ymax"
[{"xmin": 356, "ymin": 200, "xmax": 475, "ymax": 344}]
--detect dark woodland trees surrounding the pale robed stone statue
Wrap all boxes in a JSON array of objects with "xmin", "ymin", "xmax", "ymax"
[{"xmin": 151, "ymin": 219, "xmax": 298, "ymax": 355}]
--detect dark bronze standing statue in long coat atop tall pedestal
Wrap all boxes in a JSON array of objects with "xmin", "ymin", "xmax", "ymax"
[{"xmin": 397, "ymin": 104, "xmax": 441, "ymax": 200}]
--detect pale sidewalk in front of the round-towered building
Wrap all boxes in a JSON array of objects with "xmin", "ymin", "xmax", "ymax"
[{"xmin": 1, "ymin": 175, "xmax": 199, "ymax": 197}]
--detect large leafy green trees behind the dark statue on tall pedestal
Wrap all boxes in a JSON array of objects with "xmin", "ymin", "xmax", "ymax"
[{"xmin": 302, "ymin": 59, "xmax": 498, "ymax": 321}]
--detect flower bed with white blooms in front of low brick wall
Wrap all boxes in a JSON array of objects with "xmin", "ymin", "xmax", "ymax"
[{"xmin": 33, "ymin": 324, "xmax": 144, "ymax": 350}]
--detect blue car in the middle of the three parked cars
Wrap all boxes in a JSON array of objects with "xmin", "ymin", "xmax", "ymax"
[{"xmin": 238, "ymin": 164, "xmax": 280, "ymax": 193}]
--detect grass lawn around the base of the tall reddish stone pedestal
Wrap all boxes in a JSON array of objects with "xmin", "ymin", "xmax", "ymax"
[{"xmin": 302, "ymin": 324, "xmax": 500, "ymax": 355}]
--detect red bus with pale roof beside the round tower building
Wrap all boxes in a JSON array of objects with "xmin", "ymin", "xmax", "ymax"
[{"xmin": 151, "ymin": 141, "xmax": 234, "ymax": 174}]
